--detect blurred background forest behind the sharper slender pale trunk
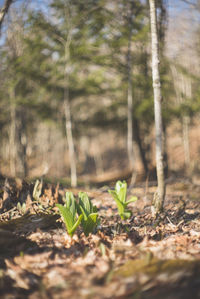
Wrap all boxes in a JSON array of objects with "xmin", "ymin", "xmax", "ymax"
[{"xmin": 0, "ymin": 0, "xmax": 200, "ymax": 186}]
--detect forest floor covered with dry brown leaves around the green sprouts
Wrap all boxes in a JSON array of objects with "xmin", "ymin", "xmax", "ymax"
[{"xmin": 0, "ymin": 179, "xmax": 200, "ymax": 299}]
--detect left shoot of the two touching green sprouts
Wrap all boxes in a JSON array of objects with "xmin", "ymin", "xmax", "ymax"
[{"xmin": 56, "ymin": 192, "xmax": 83, "ymax": 237}]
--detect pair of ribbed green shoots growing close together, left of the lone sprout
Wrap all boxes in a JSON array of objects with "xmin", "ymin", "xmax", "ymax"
[{"xmin": 56, "ymin": 192, "xmax": 98, "ymax": 237}]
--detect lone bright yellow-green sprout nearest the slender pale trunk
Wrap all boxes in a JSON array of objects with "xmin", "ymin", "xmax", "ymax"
[{"xmin": 108, "ymin": 181, "xmax": 137, "ymax": 220}]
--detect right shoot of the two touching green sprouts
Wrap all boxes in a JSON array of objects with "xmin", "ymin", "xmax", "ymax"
[{"xmin": 78, "ymin": 192, "xmax": 98, "ymax": 236}]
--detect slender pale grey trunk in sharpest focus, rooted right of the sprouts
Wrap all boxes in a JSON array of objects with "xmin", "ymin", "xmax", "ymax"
[{"xmin": 149, "ymin": 0, "xmax": 165, "ymax": 214}]
